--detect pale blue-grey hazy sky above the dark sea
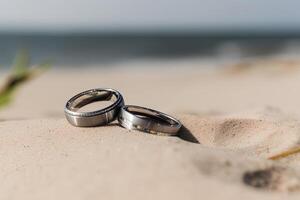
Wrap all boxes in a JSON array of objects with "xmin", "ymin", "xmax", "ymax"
[{"xmin": 0, "ymin": 0, "xmax": 300, "ymax": 33}]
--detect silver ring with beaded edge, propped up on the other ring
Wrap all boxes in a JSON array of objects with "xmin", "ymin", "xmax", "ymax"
[{"xmin": 65, "ymin": 88, "xmax": 124, "ymax": 127}]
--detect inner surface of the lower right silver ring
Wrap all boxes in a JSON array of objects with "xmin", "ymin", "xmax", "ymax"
[{"xmin": 127, "ymin": 107, "xmax": 177, "ymax": 125}]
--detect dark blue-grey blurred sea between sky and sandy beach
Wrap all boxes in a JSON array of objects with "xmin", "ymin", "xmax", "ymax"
[{"xmin": 0, "ymin": 34, "xmax": 300, "ymax": 67}]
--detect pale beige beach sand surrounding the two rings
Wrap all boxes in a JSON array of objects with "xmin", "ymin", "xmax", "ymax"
[{"xmin": 0, "ymin": 60, "xmax": 300, "ymax": 200}]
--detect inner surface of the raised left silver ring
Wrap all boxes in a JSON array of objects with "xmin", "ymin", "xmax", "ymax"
[{"xmin": 70, "ymin": 90, "xmax": 118, "ymax": 111}]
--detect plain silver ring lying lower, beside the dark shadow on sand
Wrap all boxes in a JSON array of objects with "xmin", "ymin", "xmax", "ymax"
[{"xmin": 118, "ymin": 105, "xmax": 181, "ymax": 136}]
